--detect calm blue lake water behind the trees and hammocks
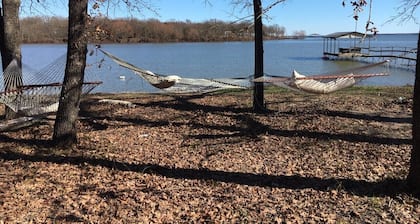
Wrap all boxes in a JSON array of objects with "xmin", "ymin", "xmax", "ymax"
[{"xmin": 3, "ymin": 34, "xmax": 417, "ymax": 92}]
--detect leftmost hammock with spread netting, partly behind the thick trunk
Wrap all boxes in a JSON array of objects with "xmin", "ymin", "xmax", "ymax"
[{"xmin": 0, "ymin": 56, "xmax": 102, "ymax": 116}]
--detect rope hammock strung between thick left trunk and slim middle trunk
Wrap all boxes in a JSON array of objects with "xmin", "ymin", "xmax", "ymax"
[{"xmin": 98, "ymin": 48, "xmax": 249, "ymax": 93}]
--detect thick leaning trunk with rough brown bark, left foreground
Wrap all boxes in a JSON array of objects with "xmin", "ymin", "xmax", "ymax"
[{"xmin": 53, "ymin": 0, "xmax": 88, "ymax": 147}]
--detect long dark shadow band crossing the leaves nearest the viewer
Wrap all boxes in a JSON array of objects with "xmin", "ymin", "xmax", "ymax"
[{"xmin": 0, "ymin": 149, "xmax": 407, "ymax": 197}]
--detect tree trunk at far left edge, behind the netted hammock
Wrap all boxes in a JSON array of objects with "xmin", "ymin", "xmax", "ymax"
[{"xmin": 0, "ymin": 0, "xmax": 22, "ymax": 119}]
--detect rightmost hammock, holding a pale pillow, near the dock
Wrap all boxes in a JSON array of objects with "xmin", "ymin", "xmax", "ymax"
[{"xmin": 253, "ymin": 61, "xmax": 389, "ymax": 94}]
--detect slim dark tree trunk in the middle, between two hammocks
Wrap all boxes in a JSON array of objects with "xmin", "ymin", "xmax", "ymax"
[{"xmin": 253, "ymin": 0, "xmax": 265, "ymax": 113}]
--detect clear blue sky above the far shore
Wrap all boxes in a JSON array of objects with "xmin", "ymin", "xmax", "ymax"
[{"xmin": 24, "ymin": 0, "xmax": 420, "ymax": 34}]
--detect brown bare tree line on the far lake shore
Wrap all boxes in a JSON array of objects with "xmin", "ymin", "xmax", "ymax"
[{"xmin": 20, "ymin": 17, "xmax": 305, "ymax": 43}]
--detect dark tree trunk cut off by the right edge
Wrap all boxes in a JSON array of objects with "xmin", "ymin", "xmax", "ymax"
[{"xmin": 407, "ymin": 31, "xmax": 420, "ymax": 197}]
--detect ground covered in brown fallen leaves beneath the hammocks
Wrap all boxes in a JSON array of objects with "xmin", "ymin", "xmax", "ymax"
[{"xmin": 0, "ymin": 87, "xmax": 420, "ymax": 223}]
